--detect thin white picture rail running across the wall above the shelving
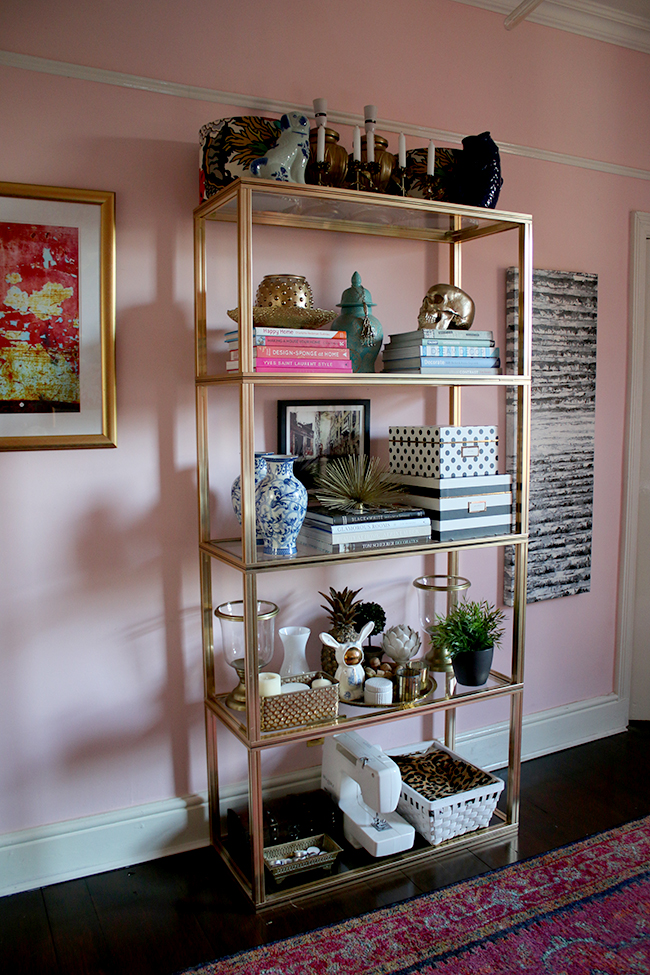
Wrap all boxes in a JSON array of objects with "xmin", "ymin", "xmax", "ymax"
[{"xmin": 0, "ymin": 50, "xmax": 650, "ymax": 180}]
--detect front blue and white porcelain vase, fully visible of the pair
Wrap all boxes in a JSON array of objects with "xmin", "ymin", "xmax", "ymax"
[{"xmin": 255, "ymin": 454, "xmax": 307, "ymax": 555}]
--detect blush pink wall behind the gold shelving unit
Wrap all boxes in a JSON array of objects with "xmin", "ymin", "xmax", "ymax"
[{"xmin": 0, "ymin": 0, "xmax": 650, "ymax": 832}]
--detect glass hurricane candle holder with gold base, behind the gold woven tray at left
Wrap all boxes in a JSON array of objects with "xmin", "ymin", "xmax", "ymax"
[{"xmin": 214, "ymin": 599, "xmax": 279, "ymax": 711}]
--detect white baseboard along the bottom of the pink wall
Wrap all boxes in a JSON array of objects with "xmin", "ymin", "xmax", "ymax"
[{"xmin": 0, "ymin": 694, "xmax": 628, "ymax": 896}]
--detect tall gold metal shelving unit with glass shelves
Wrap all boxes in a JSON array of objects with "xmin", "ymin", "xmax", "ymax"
[{"xmin": 194, "ymin": 177, "xmax": 532, "ymax": 909}]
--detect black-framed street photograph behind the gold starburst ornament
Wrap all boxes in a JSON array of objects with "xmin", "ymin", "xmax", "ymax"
[{"xmin": 278, "ymin": 399, "xmax": 370, "ymax": 489}]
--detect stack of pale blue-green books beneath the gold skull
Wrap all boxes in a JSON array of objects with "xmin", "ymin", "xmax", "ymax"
[{"xmin": 383, "ymin": 328, "xmax": 501, "ymax": 376}]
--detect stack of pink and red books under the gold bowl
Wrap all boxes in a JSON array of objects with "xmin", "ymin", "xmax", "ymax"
[{"xmin": 226, "ymin": 326, "xmax": 352, "ymax": 373}]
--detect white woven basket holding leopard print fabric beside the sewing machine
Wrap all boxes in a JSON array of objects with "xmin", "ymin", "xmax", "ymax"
[{"xmin": 390, "ymin": 742, "xmax": 505, "ymax": 846}]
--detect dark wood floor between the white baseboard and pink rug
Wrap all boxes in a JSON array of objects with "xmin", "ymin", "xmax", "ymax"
[{"xmin": 5, "ymin": 723, "xmax": 650, "ymax": 975}]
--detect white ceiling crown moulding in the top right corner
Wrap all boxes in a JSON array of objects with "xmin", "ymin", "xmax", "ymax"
[{"xmin": 454, "ymin": 0, "xmax": 650, "ymax": 54}]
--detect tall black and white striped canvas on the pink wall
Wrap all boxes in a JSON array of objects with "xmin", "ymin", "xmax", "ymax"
[{"xmin": 504, "ymin": 268, "xmax": 598, "ymax": 605}]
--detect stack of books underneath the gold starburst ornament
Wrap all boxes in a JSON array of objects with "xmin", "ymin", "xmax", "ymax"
[{"xmin": 298, "ymin": 505, "xmax": 431, "ymax": 553}]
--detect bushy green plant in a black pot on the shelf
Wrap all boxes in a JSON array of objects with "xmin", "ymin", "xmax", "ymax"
[{"xmin": 427, "ymin": 600, "xmax": 505, "ymax": 687}]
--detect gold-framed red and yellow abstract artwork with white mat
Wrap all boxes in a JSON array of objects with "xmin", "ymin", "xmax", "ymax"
[{"xmin": 0, "ymin": 183, "xmax": 116, "ymax": 450}]
